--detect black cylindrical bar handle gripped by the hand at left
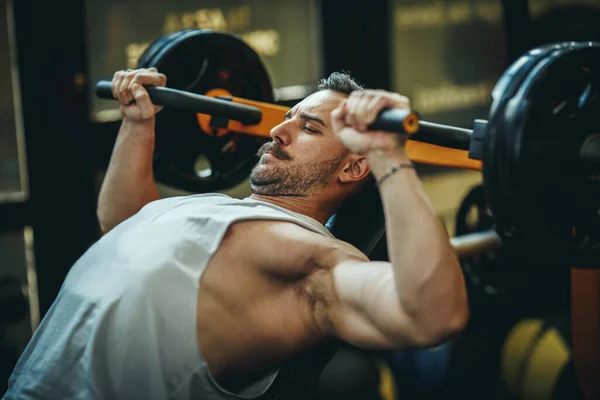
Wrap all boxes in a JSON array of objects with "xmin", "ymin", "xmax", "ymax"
[{"xmin": 96, "ymin": 81, "xmax": 262, "ymax": 125}]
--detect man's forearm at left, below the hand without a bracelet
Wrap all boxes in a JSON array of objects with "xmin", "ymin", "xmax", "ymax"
[{"xmin": 98, "ymin": 118, "xmax": 160, "ymax": 233}]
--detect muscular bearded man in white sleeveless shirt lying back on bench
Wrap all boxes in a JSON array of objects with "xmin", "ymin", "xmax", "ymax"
[{"xmin": 6, "ymin": 69, "xmax": 468, "ymax": 399}]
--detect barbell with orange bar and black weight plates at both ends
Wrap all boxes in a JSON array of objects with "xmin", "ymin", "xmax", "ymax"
[{"xmin": 96, "ymin": 30, "xmax": 600, "ymax": 268}]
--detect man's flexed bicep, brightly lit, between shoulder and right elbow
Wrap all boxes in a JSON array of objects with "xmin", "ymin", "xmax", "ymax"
[{"xmin": 328, "ymin": 261, "xmax": 416, "ymax": 349}]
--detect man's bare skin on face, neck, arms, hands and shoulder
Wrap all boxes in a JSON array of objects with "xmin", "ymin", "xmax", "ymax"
[{"xmin": 98, "ymin": 70, "xmax": 468, "ymax": 382}]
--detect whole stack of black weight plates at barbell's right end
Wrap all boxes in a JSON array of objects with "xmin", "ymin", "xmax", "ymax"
[{"xmin": 484, "ymin": 43, "xmax": 600, "ymax": 267}]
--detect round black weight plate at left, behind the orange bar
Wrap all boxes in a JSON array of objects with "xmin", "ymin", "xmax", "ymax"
[{"xmin": 146, "ymin": 30, "xmax": 274, "ymax": 193}]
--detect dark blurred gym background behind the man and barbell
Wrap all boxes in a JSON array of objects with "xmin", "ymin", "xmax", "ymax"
[{"xmin": 0, "ymin": 0, "xmax": 600, "ymax": 399}]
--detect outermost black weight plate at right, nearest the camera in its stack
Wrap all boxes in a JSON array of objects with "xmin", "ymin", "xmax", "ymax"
[{"xmin": 514, "ymin": 43, "xmax": 600, "ymax": 267}]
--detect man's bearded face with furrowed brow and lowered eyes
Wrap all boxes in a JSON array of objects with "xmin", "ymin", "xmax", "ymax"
[{"xmin": 250, "ymin": 90, "xmax": 347, "ymax": 196}]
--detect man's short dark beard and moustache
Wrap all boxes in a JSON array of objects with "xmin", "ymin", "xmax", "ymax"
[{"xmin": 250, "ymin": 142, "xmax": 347, "ymax": 197}]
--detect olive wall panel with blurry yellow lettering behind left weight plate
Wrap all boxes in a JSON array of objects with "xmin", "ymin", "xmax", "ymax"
[{"xmin": 86, "ymin": 0, "xmax": 321, "ymax": 120}]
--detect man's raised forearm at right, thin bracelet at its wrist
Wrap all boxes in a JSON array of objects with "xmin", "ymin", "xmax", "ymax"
[{"xmin": 368, "ymin": 151, "xmax": 466, "ymax": 340}]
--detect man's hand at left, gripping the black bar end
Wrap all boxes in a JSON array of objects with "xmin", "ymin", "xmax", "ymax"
[{"xmin": 111, "ymin": 68, "xmax": 167, "ymax": 123}]
